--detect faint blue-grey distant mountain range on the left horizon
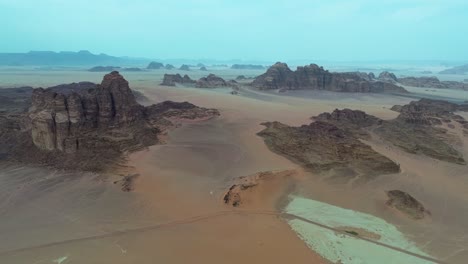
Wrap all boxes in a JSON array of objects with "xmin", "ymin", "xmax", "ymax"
[{"xmin": 0, "ymin": 50, "xmax": 150, "ymax": 66}]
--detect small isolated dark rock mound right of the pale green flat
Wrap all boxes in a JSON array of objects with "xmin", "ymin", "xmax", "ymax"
[{"xmin": 386, "ymin": 190, "xmax": 431, "ymax": 220}]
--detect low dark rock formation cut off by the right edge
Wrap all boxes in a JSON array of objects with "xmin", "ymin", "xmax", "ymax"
[{"xmin": 315, "ymin": 99, "xmax": 468, "ymax": 164}]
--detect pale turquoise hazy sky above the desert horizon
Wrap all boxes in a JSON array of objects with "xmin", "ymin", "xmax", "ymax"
[{"xmin": 0, "ymin": 0, "xmax": 468, "ymax": 61}]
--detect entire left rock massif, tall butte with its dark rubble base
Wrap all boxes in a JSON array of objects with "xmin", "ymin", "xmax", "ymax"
[{"xmin": 0, "ymin": 72, "xmax": 219, "ymax": 171}]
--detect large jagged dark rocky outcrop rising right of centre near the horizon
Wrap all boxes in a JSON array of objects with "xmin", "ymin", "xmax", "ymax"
[{"xmin": 252, "ymin": 62, "xmax": 406, "ymax": 93}]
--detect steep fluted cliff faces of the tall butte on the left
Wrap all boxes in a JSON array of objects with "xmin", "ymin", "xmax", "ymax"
[{"xmin": 29, "ymin": 71, "xmax": 144, "ymax": 152}]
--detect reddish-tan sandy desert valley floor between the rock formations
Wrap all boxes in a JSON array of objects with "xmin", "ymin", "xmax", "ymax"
[{"xmin": 0, "ymin": 71, "xmax": 468, "ymax": 264}]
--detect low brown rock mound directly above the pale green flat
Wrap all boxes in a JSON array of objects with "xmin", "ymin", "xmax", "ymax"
[{"xmin": 258, "ymin": 121, "xmax": 400, "ymax": 180}]
